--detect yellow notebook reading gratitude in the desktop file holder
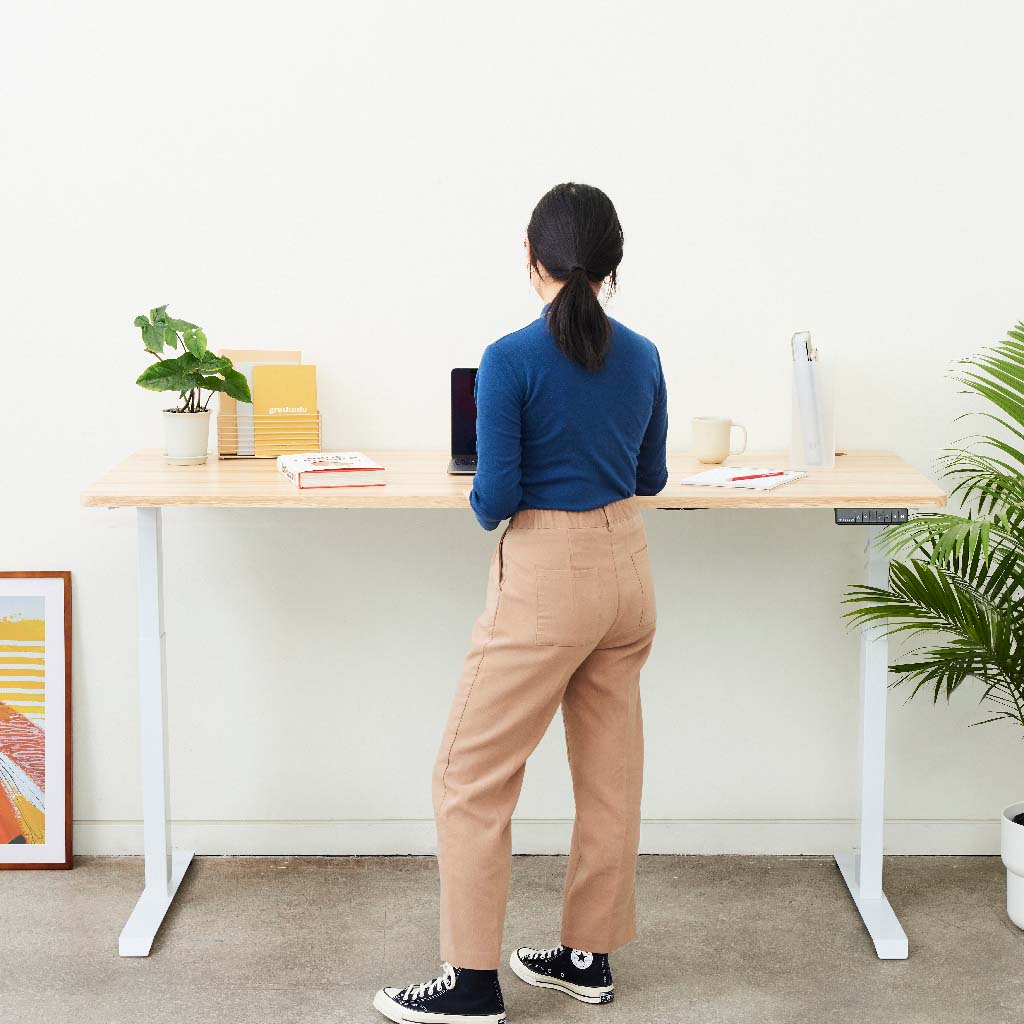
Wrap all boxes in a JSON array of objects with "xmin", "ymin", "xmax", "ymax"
[{"xmin": 253, "ymin": 365, "xmax": 317, "ymax": 459}]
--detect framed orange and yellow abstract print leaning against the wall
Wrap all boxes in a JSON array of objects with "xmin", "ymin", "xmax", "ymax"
[{"xmin": 0, "ymin": 572, "xmax": 72, "ymax": 869}]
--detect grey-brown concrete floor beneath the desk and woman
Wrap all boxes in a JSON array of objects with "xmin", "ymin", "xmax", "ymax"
[{"xmin": 0, "ymin": 856, "xmax": 1024, "ymax": 1024}]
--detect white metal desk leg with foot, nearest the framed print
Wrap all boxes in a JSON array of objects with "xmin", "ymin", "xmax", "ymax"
[{"xmin": 118, "ymin": 508, "xmax": 193, "ymax": 956}]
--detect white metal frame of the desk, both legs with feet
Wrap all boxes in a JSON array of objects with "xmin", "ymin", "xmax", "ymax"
[{"xmin": 118, "ymin": 507, "xmax": 907, "ymax": 959}]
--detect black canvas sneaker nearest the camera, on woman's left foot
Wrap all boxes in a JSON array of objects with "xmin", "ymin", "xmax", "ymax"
[{"xmin": 374, "ymin": 964, "xmax": 505, "ymax": 1024}]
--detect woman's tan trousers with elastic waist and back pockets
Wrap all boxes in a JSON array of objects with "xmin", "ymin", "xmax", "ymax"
[{"xmin": 433, "ymin": 499, "xmax": 655, "ymax": 970}]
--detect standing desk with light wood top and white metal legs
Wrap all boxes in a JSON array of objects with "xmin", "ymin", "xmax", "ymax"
[{"xmin": 82, "ymin": 451, "xmax": 946, "ymax": 959}]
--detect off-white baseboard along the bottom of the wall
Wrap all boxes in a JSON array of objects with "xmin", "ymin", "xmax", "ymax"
[{"xmin": 75, "ymin": 818, "xmax": 999, "ymax": 856}]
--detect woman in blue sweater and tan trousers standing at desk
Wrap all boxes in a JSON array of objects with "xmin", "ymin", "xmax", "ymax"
[{"xmin": 374, "ymin": 183, "xmax": 668, "ymax": 1024}]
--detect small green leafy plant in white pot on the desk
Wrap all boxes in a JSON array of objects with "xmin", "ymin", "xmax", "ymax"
[{"xmin": 135, "ymin": 305, "xmax": 253, "ymax": 466}]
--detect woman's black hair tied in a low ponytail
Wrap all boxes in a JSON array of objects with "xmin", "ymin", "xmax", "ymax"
[{"xmin": 526, "ymin": 182, "xmax": 623, "ymax": 371}]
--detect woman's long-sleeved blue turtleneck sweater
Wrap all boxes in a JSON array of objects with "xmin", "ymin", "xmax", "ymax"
[{"xmin": 469, "ymin": 307, "xmax": 669, "ymax": 529}]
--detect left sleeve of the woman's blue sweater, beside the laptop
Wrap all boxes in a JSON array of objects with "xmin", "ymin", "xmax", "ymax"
[{"xmin": 469, "ymin": 345, "xmax": 522, "ymax": 529}]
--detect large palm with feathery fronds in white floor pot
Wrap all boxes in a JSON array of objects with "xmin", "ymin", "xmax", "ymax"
[{"xmin": 845, "ymin": 324, "xmax": 1024, "ymax": 928}]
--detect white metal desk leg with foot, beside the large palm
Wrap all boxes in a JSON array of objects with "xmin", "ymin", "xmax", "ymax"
[{"xmin": 836, "ymin": 528, "xmax": 907, "ymax": 959}]
